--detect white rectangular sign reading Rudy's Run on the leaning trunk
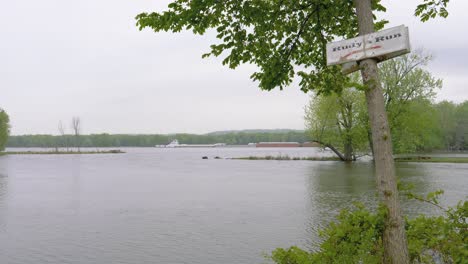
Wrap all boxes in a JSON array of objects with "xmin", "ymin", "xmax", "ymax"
[{"xmin": 327, "ymin": 25, "xmax": 411, "ymax": 73}]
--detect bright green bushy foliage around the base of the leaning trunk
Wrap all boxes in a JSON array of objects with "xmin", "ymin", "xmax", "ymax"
[{"xmin": 271, "ymin": 191, "xmax": 468, "ymax": 264}]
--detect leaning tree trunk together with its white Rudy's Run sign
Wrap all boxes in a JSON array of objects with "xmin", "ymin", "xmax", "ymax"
[{"xmin": 327, "ymin": 5, "xmax": 410, "ymax": 264}]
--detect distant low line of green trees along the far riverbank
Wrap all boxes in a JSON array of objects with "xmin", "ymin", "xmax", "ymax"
[{"xmin": 7, "ymin": 130, "xmax": 309, "ymax": 148}]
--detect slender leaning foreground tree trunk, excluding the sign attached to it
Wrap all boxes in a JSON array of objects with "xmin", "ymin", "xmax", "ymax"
[{"xmin": 354, "ymin": 0, "xmax": 409, "ymax": 264}]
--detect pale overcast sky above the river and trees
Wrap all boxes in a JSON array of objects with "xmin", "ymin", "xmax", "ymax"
[{"xmin": 0, "ymin": 0, "xmax": 468, "ymax": 135}]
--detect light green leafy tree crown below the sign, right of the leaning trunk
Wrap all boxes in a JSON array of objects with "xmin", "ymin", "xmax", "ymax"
[{"xmin": 380, "ymin": 50, "xmax": 442, "ymax": 153}]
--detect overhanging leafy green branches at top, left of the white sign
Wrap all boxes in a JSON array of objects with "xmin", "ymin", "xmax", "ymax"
[{"xmin": 136, "ymin": 0, "xmax": 386, "ymax": 93}]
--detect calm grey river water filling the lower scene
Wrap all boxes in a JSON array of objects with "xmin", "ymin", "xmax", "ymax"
[{"xmin": 0, "ymin": 148, "xmax": 468, "ymax": 264}]
